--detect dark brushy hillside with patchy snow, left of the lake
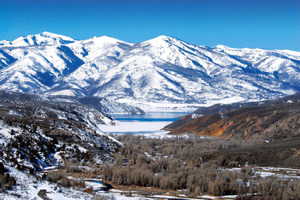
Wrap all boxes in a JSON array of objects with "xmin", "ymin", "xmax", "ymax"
[{"xmin": 0, "ymin": 91, "xmax": 122, "ymax": 199}]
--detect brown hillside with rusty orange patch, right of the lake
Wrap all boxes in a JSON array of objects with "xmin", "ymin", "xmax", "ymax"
[{"xmin": 165, "ymin": 94, "xmax": 300, "ymax": 142}]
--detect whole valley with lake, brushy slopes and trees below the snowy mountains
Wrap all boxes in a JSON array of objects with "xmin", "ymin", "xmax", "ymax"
[{"xmin": 0, "ymin": 91, "xmax": 300, "ymax": 200}]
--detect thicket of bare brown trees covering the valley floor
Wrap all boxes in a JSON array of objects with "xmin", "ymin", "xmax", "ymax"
[{"xmin": 102, "ymin": 136, "xmax": 300, "ymax": 200}]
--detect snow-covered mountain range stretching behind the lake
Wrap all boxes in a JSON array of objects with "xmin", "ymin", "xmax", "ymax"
[{"xmin": 0, "ymin": 32, "xmax": 300, "ymax": 110}]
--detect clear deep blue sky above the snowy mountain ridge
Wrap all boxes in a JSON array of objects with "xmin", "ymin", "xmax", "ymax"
[{"xmin": 0, "ymin": 0, "xmax": 300, "ymax": 51}]
